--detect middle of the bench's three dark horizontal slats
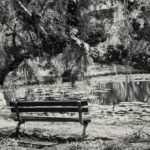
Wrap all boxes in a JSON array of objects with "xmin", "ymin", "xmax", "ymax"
[{"xmin": 11, "ymin": 107, "xmax": 88, "ymax": 113}]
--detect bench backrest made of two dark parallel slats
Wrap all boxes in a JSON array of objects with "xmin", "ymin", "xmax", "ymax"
[{"xmin": 9, "ymin": 101, "xmax": 88, "ymax": 113}]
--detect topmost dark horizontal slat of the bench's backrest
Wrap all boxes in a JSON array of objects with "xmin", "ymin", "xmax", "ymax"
[{"xmin": 9, "ymin": 101, "xmax": 88, "ymax": 107}]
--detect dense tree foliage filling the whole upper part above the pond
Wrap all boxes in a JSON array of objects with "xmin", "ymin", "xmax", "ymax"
[{"xmin": 0, "ymin": 0, "xmax": 150, "ymax": 84}]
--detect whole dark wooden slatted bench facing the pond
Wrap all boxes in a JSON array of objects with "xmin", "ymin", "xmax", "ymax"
[{"xmin": 9, "ymin": 101, "xmax": 91, "ymax": 137}]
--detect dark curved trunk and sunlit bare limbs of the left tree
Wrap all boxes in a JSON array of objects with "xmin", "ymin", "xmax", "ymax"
[{"xmin": 0, "ymin": 0, "xmax": 90, "ymax": 86}]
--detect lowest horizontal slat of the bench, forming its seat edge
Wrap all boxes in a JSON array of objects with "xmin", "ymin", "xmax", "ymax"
[{"xmin": 15, "ymin": 116, "xmax": 91, "ymax": 122}]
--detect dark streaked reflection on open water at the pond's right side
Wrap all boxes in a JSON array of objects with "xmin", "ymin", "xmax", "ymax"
[{"xmin": 101, "ymin": 81, "xmax": 150, "ymax": 104}]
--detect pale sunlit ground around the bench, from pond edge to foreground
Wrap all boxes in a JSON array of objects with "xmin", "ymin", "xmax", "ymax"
[{"xmin": 0, "ymin": 102, "xmax": 150, "ymax": 150}]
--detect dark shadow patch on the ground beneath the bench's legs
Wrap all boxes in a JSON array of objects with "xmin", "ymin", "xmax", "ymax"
[{"xmin": 0, "ymin": 128, "xmax": 112, "ymax": 149}]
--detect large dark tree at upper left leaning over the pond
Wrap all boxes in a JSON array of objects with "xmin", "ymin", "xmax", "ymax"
[{"xmin": 0, "ymin": 0, "xmax": 92, "ymax": 85}]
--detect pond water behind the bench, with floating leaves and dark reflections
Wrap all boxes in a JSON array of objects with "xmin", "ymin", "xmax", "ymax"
[{"xmin": 4, "ymin": 81, "xmax": 150, "ymax": 104}]
